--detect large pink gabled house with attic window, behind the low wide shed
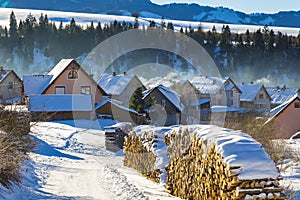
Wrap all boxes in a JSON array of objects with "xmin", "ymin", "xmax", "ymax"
[{"xmin": 24, "ymin": 59, "xmax": 106, "ymax": 119}]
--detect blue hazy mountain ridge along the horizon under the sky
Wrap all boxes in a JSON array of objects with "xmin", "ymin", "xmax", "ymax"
[{"xmin": 0, "ymin": 0, "xmax": 300, "ymax": 28}]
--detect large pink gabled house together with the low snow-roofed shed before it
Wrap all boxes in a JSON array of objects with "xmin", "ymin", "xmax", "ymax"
[{"xmin": 24, "ymin": 59, "xmax": 106, "ymax": 119}]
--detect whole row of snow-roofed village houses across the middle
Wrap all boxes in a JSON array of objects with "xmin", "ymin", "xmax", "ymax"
[{"xmin": 0, "ymin": 59, "xmax": 300, "ymax": 138}]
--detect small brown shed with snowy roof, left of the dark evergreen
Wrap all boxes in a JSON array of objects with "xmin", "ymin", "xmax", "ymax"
[{"xmin": 95, "ymin": 99, "xmax": 145, "ymax": 124}]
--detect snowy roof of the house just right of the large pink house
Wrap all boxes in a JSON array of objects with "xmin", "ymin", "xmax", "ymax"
[{"xmin": 98, "ymin": 74, "xmax": 135, "ymax": 95}]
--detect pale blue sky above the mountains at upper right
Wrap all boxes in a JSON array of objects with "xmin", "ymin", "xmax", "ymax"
[{"xmin": 151, "ymin": 0, "xmax": 300, "ymax": 13}]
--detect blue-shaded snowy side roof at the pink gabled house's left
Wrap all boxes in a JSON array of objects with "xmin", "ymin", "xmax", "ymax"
[{"xmin": 23, "ymin": 75, "xmax": 53, "ymax": 96}]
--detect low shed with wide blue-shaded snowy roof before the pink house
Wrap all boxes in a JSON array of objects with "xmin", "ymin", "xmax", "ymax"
[{"xmin": 28, "ymin": 94, "xmax": 94, "ymax": 120}]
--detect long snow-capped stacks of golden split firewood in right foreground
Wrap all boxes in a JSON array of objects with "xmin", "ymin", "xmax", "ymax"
[{"xmin": 124, "ymin": 125, "xmax": 284, "ymax": 200}]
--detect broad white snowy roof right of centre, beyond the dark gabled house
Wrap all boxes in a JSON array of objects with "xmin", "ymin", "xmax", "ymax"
[{"xmin": 191, "ymin": 76, "xmax": 231, "ymax": 94}]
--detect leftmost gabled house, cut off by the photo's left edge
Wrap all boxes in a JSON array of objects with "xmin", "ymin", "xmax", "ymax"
[{"xmin": 0, "ymin": 67, "xmax": 22, "ymax": 103}]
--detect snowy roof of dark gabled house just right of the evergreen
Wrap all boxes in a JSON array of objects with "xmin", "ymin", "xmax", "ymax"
[{"xmin": 143, "ymin": 85, "xmax": 184, "ymax": 111}]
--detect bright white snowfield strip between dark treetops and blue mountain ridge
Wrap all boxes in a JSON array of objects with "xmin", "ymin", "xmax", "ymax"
[{"xmin": 0, "ymin": 8, "xmax": 299, "ymax": 36}]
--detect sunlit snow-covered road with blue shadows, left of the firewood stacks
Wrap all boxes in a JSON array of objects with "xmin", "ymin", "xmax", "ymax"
[{"xmin": 4, "ymin": 120, "xmax": 176, "ymax": 200}]
